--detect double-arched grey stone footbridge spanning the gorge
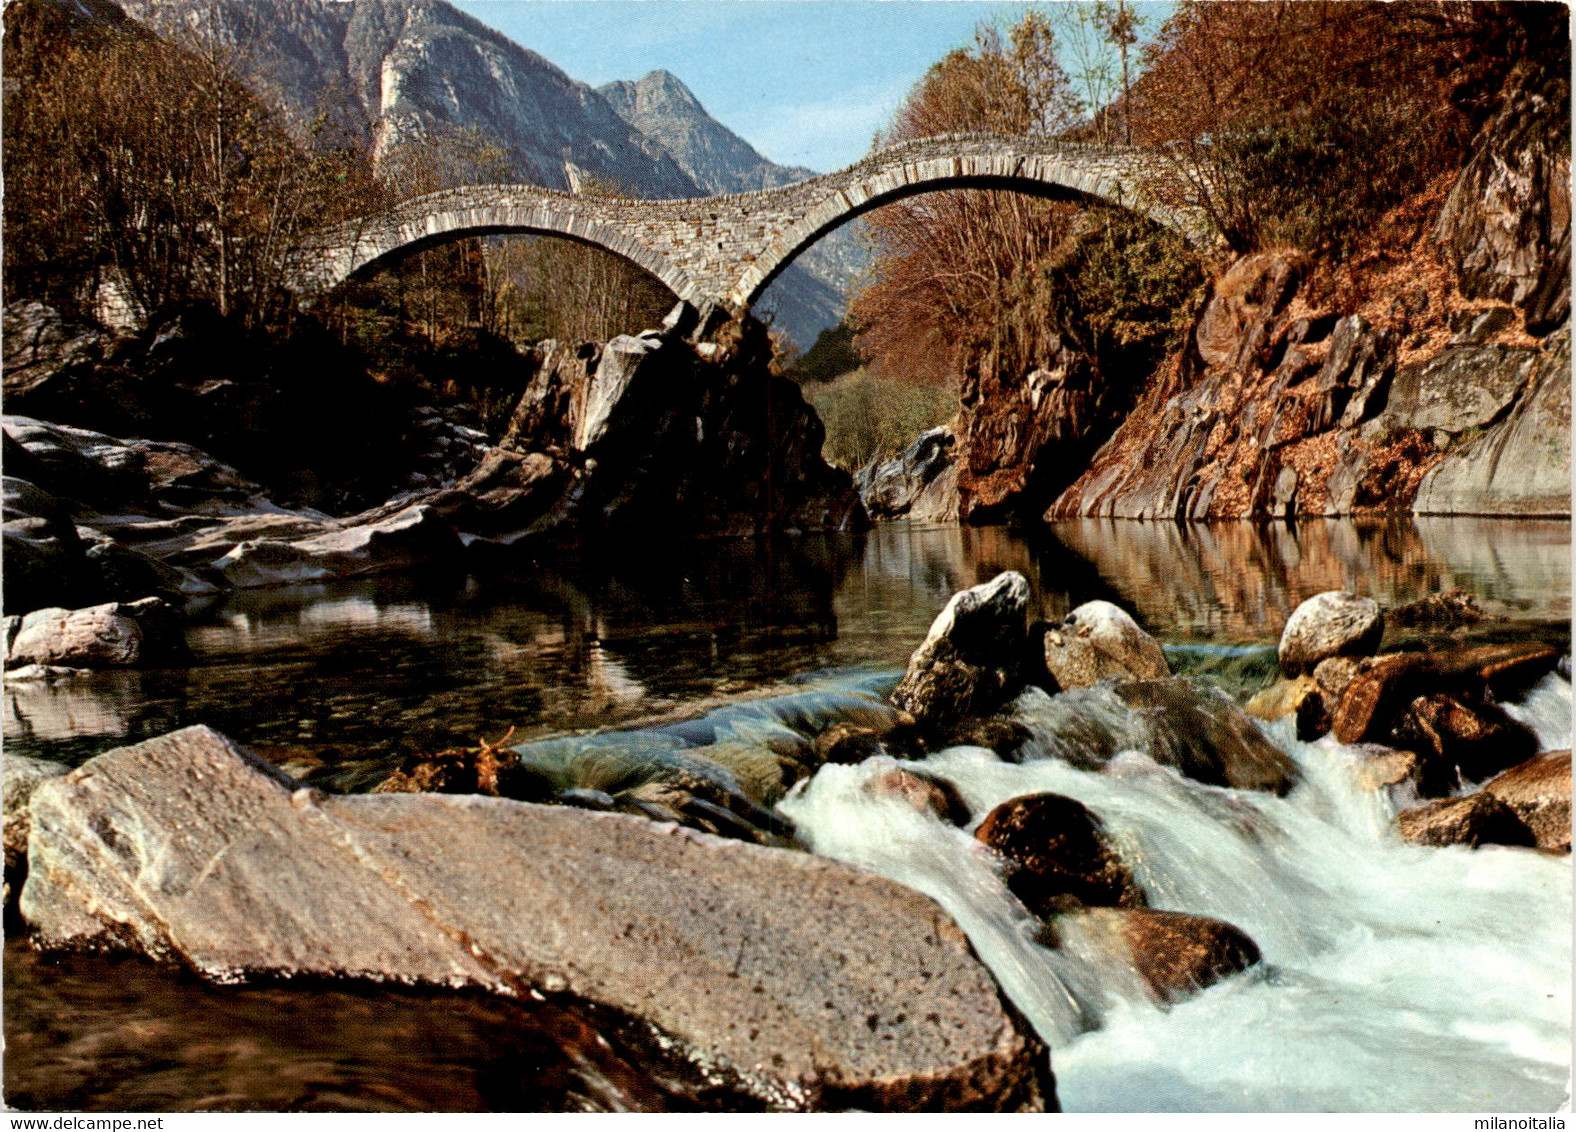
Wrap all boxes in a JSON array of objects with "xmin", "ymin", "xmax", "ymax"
[{"xmin": 295, "ymin": 134, "xmax": 1215, "ymax": 311}]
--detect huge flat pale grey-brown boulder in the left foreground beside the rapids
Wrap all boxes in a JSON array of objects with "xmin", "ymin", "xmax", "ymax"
[{"xmin": 20, "ymin": 727, "xmax": 1043, "ymax": 1108}]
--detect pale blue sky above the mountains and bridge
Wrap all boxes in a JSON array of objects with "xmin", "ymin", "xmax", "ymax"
[{"xmin": 454, "ymin": 0, "xmax": 1171, "ymax": 172}]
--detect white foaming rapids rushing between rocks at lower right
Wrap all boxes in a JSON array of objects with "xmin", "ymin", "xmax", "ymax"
[{"xmin": 780, "ymin": 675, "xmax": 1571, "ymax": 1112}]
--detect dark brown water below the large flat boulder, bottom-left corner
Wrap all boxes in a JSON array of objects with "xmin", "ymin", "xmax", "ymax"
[{"xmin": 5, "ymin": 941, "xmax": 724, "ymax": 1112}]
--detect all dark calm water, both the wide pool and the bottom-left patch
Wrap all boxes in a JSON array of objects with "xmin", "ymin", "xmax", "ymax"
[{"xmin": 5, "ymin": 519, "xmax": 1571, "ymax": 1110}]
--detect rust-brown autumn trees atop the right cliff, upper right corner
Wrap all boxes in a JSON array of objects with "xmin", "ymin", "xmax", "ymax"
[{"xmin": 1124, "ymin": 0, "xmax": 1570, "ymax": 251}]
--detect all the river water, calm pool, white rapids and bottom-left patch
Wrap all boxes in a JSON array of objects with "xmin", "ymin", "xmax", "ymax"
[{"xmin": 5, "ymin": 519, "xmax": 1571, "ymax": 1112}]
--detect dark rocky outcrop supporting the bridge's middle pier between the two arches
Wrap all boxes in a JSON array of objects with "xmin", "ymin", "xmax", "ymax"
[{"xmin": 441, "ymin": 320, "xmax": 865, "ymax": 541}]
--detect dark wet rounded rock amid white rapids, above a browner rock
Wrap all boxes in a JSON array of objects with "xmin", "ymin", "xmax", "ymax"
[{"xmin": 974, "ymin": 795, "xmax": 1147, "ymax": 918}]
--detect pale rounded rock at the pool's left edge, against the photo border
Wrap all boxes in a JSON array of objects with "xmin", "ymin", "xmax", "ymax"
[{"xmin": 5, "ymin": 598, "xmax": 186, "ymax": 668}]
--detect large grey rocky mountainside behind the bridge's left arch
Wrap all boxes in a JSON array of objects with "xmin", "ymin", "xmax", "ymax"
[{"xmin": 123, "ymin": 0, "xmax": 703, "ymax": 197}]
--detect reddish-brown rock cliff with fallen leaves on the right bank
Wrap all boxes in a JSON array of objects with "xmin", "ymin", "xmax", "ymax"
[{"xmin": 1046, "ymin": 62, "xmax": 1571, "ymax": 519}]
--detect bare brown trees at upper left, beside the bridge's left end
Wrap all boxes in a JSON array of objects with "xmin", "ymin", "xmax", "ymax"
[{"xmin": 5, "ymin": 5, "xmax": 369, "ymax": 326}]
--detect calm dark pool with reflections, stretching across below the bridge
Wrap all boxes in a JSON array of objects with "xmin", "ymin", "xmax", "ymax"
[{"xmin": 5, "ymin": 519, "xmax": 1570, "ymax": 790}]
